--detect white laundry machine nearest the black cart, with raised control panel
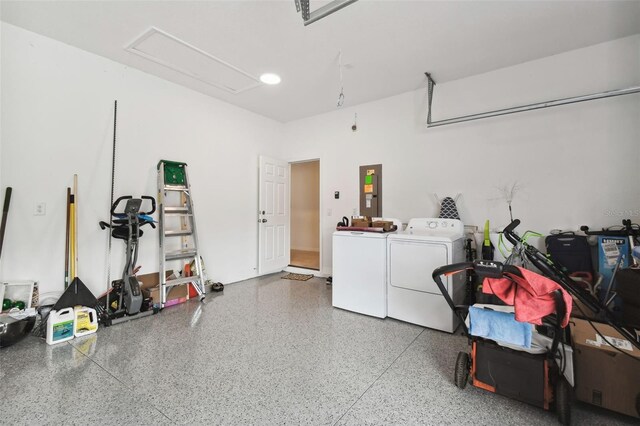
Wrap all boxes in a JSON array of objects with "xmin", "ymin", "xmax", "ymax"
[{"xmin": 387, "ymin": 218, "xmax": 466, "ymax": 333}]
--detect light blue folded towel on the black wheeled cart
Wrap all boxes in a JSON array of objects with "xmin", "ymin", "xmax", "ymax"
[{"xmin": 469, "ymin": 306, "xmax": 532, "ymax": 348}]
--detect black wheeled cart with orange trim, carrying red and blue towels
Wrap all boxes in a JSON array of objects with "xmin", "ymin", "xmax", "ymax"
[{"xmin": 433, "ymin": 260, "xmax": 572, "ymax": 424}]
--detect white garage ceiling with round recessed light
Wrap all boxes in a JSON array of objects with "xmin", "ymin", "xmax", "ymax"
[{"xmin": 0, "ymin": 0, "xmax": 640, "ymax": 122}]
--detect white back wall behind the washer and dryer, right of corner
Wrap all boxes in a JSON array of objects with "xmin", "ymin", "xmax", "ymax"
[{"xmin": 285, "ymin": 35, "xmax": 640, "ymax": 273}]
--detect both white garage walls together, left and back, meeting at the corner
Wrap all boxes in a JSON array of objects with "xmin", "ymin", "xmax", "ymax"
[{"xmin": 0, "ymin": 23, "xmax": 640, "ymax": 293}]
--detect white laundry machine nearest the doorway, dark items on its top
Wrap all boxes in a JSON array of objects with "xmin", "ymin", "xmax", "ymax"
[{"xmin": 331, "ymin": 219, "xmax": 402, "ymax": 318}]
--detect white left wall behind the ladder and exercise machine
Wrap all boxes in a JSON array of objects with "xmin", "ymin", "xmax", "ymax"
[{"xmin": 0, "ymin": 23, "xmax": 282, "ymax": 293}]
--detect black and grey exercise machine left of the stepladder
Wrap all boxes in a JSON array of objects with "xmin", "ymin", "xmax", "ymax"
[{"xmin": 99, "ymin": 195, "xmax": 156, "ymax": 325}]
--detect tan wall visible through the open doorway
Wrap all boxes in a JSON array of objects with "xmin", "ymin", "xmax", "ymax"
[{"xmin": 291, "ymin": 161, "xmax": 320, "ymax": 251}]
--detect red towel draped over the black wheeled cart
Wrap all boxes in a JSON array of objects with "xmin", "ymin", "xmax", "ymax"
[{"xmin": 482, "ymin": 267, "xmax": 573, "ymax": 327}]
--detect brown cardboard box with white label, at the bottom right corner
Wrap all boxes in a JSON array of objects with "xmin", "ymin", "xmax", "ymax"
[{"xmin": 571, "ymin": 318, "xmax": 640, "ymax": 418}]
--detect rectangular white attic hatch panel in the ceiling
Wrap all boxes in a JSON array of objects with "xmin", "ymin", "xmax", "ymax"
[{"xmin": 125, "ymin": 27, "xmax": 262, "ymax": 95}]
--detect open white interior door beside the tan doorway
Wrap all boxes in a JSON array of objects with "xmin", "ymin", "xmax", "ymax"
[{"xmin": 258, "ymin": 155, "xmax": 290, "ymax": 275}]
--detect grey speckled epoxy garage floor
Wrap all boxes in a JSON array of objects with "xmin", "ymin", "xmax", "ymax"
[{"xmin": 0, "ymin": 274, "xmax": 637, "ymax": 425}]
